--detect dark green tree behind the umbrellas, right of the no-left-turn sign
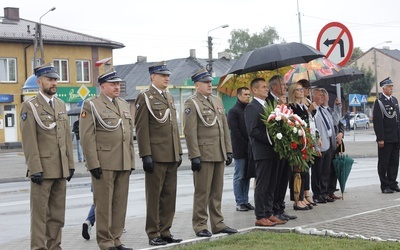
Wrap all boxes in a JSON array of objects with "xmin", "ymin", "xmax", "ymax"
[{"xmin": 343, "ymin": 63, "xmax": 375, "ymax": 101}]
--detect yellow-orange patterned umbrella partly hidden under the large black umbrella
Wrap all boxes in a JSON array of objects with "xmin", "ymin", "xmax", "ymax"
[{"xmin": 217, "ymin": 66, "xmax": 292, "ymax": 97}]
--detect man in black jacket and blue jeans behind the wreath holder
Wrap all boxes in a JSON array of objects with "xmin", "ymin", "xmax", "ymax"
[{"xmin": 228, "ymin": 87, "xmax": 254, "ymax": 211}]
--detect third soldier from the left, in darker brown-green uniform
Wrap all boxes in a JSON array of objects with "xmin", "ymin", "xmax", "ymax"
[{"xmin": 135, "ymin": 62, "xmax": 182, "ymax": 246}]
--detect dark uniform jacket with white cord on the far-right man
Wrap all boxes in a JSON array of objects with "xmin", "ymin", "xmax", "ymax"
[{"xmin": 373, "ymin": 95, "xmax": 400, "ymax": 142}]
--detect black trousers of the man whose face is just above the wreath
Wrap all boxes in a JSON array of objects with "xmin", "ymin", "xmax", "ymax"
[{"xmin": 273, "ymin": 157, "xmax": 290, "ymax": 214}]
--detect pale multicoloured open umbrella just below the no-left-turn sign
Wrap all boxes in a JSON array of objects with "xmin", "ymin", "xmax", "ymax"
[{"xmin": 284, "ymin": 57, "xmax": 341, "ymax": 83}]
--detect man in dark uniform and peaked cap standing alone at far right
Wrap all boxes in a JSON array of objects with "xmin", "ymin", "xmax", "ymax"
[{"xmin": 373, "ymin": 77, "xmax": 400, "ymax": 194}]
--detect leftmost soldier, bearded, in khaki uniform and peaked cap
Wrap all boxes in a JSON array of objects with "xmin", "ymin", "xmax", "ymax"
[{"xmin": 21, "ymin": 64, "xmax": 75, "ymax": 249}]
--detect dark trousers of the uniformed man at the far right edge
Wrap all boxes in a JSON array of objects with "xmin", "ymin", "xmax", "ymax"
[{"xmin": 378, "ymin": 142, "xmax": 399, "ymax": 190}]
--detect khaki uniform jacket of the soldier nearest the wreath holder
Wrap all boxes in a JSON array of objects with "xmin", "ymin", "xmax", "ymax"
[{"xmin": 184, "ymin": 92, "xmax": 232, "ymax": 162}]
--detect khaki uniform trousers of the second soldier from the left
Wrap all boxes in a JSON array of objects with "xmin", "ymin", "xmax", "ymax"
[{"xmin": 92, "ymin": 170, "xmax": 130, "ymax": 249}]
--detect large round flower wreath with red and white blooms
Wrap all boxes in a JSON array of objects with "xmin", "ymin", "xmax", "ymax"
[{"xmin": 262, "ymin": 104, "xmax": 315, "ymax": 171}]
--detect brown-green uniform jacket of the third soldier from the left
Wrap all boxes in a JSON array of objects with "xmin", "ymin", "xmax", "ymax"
[{"xmin": 135, "ymin": 86, "xmax": 182, "ymax": 162}]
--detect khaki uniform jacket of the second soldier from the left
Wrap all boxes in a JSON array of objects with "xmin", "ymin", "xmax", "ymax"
[{"xmin": 79, "ymin": 93, "xmax": 135, "ymax": 171}]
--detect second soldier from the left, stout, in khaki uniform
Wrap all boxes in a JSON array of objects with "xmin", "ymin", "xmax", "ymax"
[{"xmin": 79, "ymin": 68, "xmax": 135, "ymax": 250}]
